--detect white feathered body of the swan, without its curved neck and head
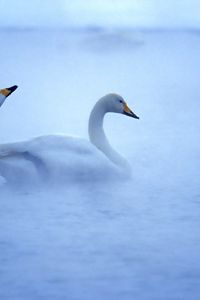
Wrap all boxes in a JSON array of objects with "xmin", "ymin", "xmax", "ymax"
[{"xmin": 0, "ymin": 135, "xmax": 117, "ymax": 182}]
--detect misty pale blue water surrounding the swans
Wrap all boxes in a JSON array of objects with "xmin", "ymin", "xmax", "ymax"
[{"xmin": 0, "ymin": 28, "xmax": 200, "ymax": 300}]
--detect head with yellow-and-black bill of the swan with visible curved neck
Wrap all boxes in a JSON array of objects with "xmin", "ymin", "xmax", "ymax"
[{"xmin": 104, "ymin": 93, "xmax": 139, "ymax": 119}]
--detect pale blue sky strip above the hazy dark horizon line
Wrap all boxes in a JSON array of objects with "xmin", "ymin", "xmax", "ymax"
[{"xmin": 0, "ymin": 0, "xmax": 200, "ymax": 27}]
